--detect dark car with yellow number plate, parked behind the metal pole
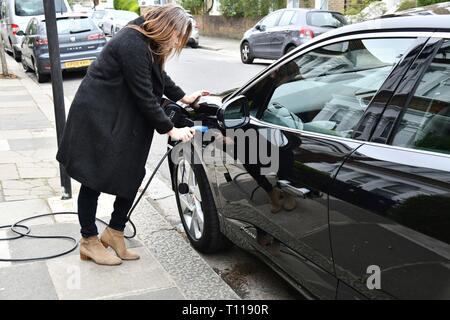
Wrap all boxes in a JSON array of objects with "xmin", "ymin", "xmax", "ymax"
[{"xmin": 19, "ymin": 14, "xmax": 106, "ymax": 82}]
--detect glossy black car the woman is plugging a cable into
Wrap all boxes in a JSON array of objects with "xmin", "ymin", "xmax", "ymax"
[{"xmin": 168, "ymin": 16, "xmax": 450, "ymax": 299}]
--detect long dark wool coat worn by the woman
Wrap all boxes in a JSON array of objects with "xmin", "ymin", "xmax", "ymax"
[{"xmin": 56, "ymin": 17, "xmax": 185, "ymax": 199}]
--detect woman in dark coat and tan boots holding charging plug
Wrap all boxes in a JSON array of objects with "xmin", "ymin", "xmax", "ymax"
[{"xmin": 56, "ymin": 5, "xmax": 207, "ymax": 265}]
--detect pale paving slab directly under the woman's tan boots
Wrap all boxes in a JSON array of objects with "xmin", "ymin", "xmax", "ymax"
[{"xmin": 47, "ymin": 248, "xmax": 174, "ymax": 299}]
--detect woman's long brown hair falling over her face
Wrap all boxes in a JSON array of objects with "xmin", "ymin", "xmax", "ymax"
[{"xmin": 129, "ymin": 4, "xmax": 192, "ymax": 68}]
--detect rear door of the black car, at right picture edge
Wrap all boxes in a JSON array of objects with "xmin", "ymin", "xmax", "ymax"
[{"xmin": 330, "ymin": 38, "xmax": 450, "ymax": 299}]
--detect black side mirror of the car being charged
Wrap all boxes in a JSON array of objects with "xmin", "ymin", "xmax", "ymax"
[{"xmin": 217, "ymin": 95, "xmax": 250, "ymax": 129}]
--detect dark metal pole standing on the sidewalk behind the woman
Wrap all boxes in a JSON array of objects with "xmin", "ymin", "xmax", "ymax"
[{"xmin": 44, "ymin": 0, "xmax": 72, "ymax": 200}]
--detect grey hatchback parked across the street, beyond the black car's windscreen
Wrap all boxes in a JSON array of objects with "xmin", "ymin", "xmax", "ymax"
[{"xmin": 241, "ymin": 9, "xmax": 347, "ymax": 64}]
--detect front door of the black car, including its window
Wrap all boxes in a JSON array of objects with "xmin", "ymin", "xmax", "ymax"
[{"xmin": 216, "ymin": 34, "xmax": 425, "ymax": 299}]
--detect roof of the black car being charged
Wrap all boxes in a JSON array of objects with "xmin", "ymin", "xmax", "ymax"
[{"xmin": 318, "ymin": 15, "xmax": 450, "ymax": 38}]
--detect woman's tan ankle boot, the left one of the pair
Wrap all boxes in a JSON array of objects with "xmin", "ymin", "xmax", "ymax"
[{"xmin": 80, "ymin": 236, "xmax": 122, "ymax": 266}]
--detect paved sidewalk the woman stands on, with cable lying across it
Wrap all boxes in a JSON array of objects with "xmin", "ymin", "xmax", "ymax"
[{"xmin": 0, "ymin": 53, "xmax": 238, "ymax": 300}]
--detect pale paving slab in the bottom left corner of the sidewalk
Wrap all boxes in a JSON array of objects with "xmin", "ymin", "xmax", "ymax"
[{"xmin": 0, "ymin": 262, "xmax": 58, "ymax": 300}]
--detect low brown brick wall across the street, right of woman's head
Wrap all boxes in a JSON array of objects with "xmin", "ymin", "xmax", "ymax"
[{"xmin": 195, "ymin": 16, "xmax": 260, "ymax": 40}]
